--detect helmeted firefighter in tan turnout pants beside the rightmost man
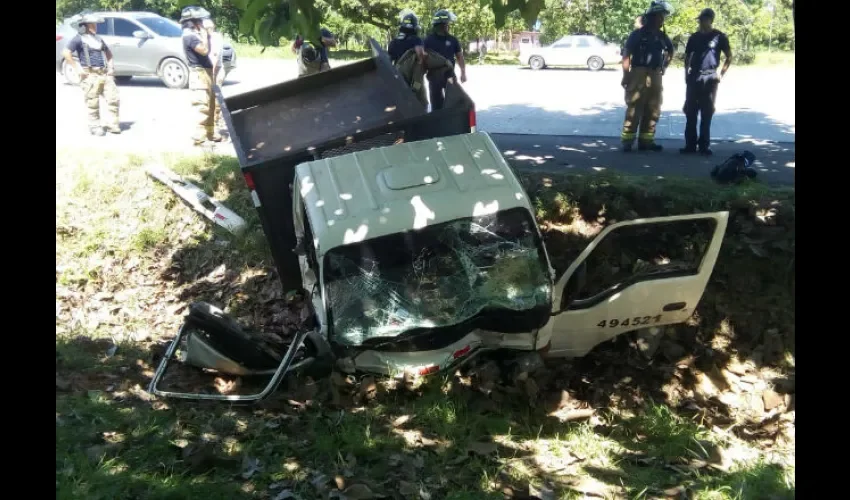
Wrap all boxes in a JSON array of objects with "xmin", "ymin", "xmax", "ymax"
[{"xmin": 620, "ymin": 0, "xmax": 673, "ymax": 152}]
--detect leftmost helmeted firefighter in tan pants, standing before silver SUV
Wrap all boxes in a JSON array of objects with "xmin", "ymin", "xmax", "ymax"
[{"xmin": 62, "ymin": 12, "xmax": 121, "ymax": 136}]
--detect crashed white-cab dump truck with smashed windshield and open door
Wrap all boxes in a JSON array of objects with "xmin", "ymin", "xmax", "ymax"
[{"xmin": 149, "ymin": 41, "xmax": 728, "ymax": 402}]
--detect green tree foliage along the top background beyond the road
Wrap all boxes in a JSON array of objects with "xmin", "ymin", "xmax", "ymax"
[{"xmin": 56, "ymin": 0, "xmax": 794, "ymax": 54}]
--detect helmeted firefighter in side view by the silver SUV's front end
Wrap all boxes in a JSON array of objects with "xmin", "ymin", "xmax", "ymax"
[{"xmin": 180, "ymin": 6, "xmax": 222, "ymax": 146}]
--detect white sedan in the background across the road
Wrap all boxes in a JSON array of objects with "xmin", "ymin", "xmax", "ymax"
[{"xmin": 519, "ymin": 35, "xmax": 622, "ymax": 71}]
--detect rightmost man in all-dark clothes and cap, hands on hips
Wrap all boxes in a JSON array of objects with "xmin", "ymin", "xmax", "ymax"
[{"xmin": 679, "ymin": 9, "xmax": 732, "ymax": 156}]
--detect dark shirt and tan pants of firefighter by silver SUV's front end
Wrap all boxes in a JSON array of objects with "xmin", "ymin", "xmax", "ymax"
[{"xmin": 183, "ymin": 29, "xmax": 221, "ymax": 144}]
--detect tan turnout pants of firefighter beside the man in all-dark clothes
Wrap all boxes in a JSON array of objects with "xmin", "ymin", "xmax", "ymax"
[{"xmin": 620, "ymin": 67, "xmax": 664, "ymax": 144}]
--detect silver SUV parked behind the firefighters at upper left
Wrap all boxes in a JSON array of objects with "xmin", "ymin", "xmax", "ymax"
[{"xmin": 56, "ymin": 12, "xmax": 236, "ymax": 89}]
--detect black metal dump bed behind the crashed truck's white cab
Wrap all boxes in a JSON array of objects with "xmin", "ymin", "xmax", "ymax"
[{"xmin": 218, "ymin": 40, "xmax": 475, "ymax": 290}]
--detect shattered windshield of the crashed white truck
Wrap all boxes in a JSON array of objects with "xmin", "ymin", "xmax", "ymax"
[{"xmin": 324, "ymin": 208, "xmax": 551, "ymax": 346}]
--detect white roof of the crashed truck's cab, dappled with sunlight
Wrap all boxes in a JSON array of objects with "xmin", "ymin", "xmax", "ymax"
[{"xmin": 296, "ymin": 132, "xmax": 531, "ymax": 256}]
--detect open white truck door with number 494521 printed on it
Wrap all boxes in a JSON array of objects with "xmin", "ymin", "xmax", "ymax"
[{"xmin": 548, "ymin": 212, "xmax": 729, "ymax": 357}]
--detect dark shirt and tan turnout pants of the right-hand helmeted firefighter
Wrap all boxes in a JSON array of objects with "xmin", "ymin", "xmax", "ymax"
[{"xmin": 620, "ymin": 26, "xmax": 673, "ymax": 147}]
